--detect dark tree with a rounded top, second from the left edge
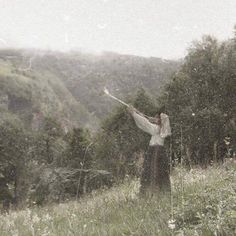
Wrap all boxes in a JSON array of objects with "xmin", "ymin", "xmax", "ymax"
[{"xmin": 28, "ymin": 117, "xmax": 68, "ymax": 204}]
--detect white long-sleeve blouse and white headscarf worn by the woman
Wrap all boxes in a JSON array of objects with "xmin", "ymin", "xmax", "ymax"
[{"xmin": 132, "ymin": 111, "xmax": 171, "ymax": 146}]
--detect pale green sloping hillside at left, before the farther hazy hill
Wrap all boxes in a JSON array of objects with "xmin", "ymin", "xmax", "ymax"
[{"xmin": 0, "ymin": 53, "xmax": 96, "ymax": 130}]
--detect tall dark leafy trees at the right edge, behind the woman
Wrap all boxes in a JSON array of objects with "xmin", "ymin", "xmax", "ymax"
[{"xmin": 160, "ymin": 36, "xmax": 236, "ymax": 165}]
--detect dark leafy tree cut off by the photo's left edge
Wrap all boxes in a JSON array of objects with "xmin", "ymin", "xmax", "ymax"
[{"xmin": 0, "ymin": 119, "xmax": 29, "ymax": 206}]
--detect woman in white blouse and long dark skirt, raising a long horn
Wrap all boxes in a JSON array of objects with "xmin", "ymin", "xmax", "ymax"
[{"xmin": 129, "ymin": 106, "xmax": 171, "ymax": 194}]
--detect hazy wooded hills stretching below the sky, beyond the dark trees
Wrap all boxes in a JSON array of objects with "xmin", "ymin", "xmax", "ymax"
[{"xmin": 0, "ymin": 50, "xmax": 180, "ymax": 129}]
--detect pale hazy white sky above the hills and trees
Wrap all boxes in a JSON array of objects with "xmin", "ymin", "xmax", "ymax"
[{"xmin": 0, "ymin": 0, "xmax": 236, "ymax": 58}]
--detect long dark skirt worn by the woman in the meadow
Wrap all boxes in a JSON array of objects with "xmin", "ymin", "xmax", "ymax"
[{"xmin": 140, "ymin": 145, "xmax": 170, "ymax": 195}]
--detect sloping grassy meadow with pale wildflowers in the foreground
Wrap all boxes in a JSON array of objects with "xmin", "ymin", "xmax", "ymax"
[{"xmin": 0, "ymin": 160, "xmax": 236, "ymax": 236}]
